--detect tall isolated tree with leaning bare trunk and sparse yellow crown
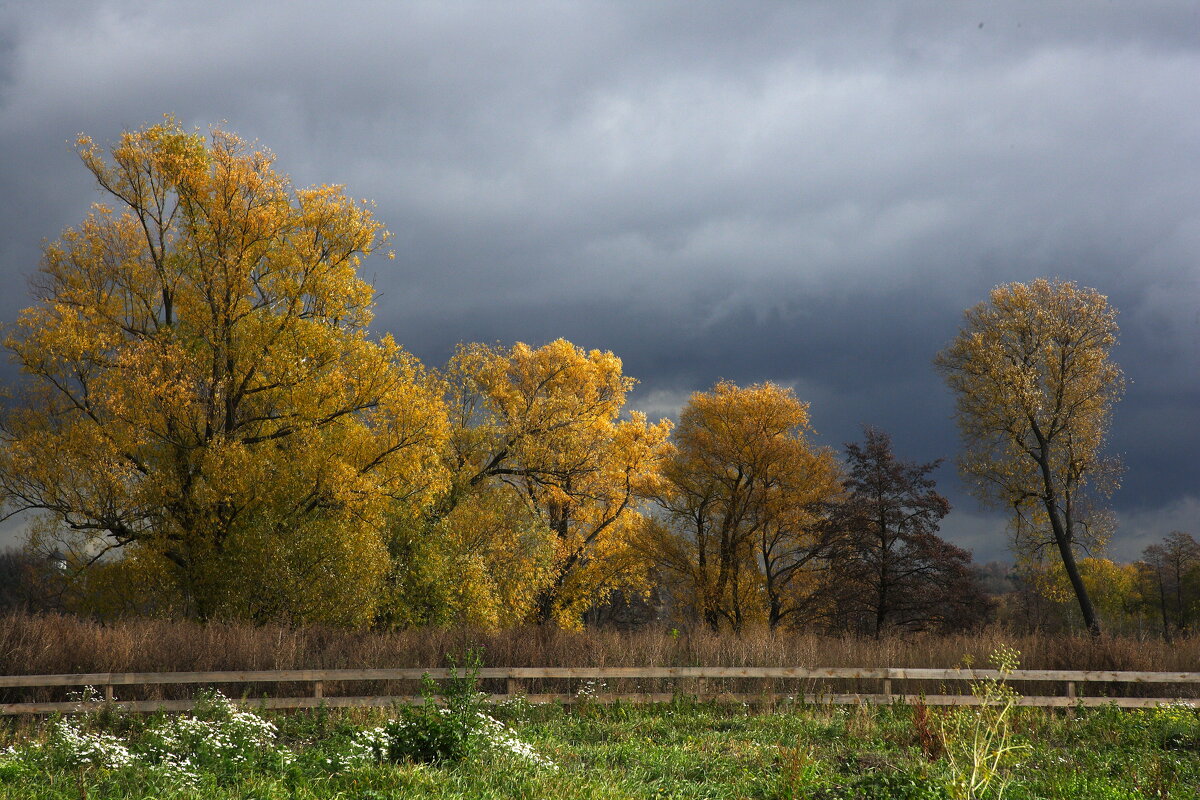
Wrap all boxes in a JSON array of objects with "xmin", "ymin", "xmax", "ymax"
[{"xmin": 935, "ymin": 278, "xmax": 1124, "ymax": 636}]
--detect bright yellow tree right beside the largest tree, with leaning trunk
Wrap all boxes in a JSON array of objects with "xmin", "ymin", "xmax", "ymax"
[{"xmin": 405, "ymin": 339, "xmax": 671, "ymax": 627}]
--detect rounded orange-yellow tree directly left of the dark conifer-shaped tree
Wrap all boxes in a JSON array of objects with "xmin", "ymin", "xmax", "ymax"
[{"xmin": 647, "ymin": 381, "xmax": 841, "ymax": 630}]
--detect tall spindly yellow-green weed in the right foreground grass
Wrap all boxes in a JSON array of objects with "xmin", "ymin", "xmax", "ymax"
[{"xmin": 941, "ymin": 644, "xmax": 1028, "ymax": 800}]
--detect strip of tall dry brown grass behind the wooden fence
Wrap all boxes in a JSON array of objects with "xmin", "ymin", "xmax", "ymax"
[{"xmin": 0, "ymin": 614, "xmax": 1200, "ymax": 699}]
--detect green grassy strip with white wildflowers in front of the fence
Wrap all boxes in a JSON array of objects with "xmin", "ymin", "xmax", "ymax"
[{"xmin": 0, "ymin": 676, "xmax": 1200, "ymax": 800}]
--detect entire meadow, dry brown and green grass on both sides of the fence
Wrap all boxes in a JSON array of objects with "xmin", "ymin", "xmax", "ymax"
[{"xmin": 0, "ymin": 614, "xmax": 1200, "ymax": 800}]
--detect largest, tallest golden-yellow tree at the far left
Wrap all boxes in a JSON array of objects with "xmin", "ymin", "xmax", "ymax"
[{"xmin": 0, "ymin": 118, "xmax": 446, "ymax": 624}]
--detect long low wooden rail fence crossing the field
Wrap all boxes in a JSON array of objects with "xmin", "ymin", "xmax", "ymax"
[{"xmin": 0, "ymin": 667, "xmax": 1200, "ymax": 714}]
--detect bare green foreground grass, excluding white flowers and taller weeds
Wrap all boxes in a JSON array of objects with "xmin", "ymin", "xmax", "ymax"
[{"xmin": 0, "ymin": 700, "xmax": 1200, "ymax": 800}]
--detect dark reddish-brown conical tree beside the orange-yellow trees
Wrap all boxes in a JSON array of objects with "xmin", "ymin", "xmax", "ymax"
[{"xmin": 829, "ymin": 427, "xmax": 988, "ymax": 638}]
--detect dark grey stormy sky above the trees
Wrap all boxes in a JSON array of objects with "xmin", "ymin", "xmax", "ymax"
[{"xmin": 0, "ymin": 0, "xmax": 1200, "ymax": 561}]
